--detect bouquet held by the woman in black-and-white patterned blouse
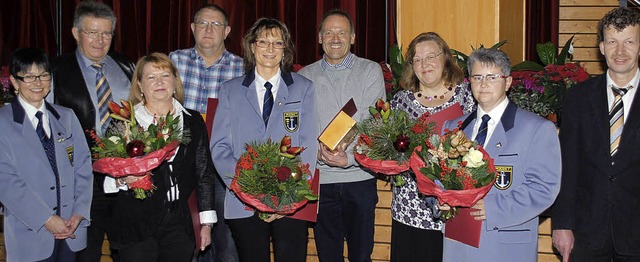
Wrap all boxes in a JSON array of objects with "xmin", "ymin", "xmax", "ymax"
[{"xmin": 354, "ymin": 99, "xmax": 435, "ymax": 186}]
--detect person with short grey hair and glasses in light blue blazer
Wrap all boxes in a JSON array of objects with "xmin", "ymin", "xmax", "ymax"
[{"xmin": 443, "ymin": 48, "xmax": 561, "ymax": 262}]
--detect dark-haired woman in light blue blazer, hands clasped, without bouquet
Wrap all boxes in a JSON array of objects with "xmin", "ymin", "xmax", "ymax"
[{"xmin": 0, "ymin": 48, "xmax": 93, "ymax": 261}]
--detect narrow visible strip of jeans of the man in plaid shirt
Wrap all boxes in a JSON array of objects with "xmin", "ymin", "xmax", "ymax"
[{"xmin": 198, "ymin": 173, "xmax": 240, "ymax": 262}]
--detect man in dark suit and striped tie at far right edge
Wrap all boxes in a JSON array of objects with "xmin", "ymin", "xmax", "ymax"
[{"xmin": 552, "ymin": 8, "xmax": 640, "ymax": 262}]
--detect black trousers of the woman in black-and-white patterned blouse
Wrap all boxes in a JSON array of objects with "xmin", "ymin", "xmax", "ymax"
[{"xmin": 391, "ymin": 220, "xmax": 443, "ymax": 262}]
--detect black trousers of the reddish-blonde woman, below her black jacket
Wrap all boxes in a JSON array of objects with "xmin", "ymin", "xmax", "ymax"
[{"xmin": 118, "ymin": 213, "xmax": 196, "ymax": 262}]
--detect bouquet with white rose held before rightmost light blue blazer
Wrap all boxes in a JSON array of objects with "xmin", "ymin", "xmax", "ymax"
[{"xmin": 410, "ymin": 125, "xmax": 498, "ymax": 220}]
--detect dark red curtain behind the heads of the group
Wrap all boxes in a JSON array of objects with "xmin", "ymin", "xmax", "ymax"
[{"xmin": 0, "ymin": 0, "xmax": 396, "ymax": 65}]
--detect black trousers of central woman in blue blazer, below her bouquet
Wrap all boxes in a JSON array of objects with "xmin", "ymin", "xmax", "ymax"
[{"xmin": 227, "ymin": 213, "xmax": 309, "ymax": 262}]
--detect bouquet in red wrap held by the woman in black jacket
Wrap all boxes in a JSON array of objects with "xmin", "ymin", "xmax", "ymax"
[{"xmin": 90, "ymin": 100, "xmax": 188, "ymax": 199}]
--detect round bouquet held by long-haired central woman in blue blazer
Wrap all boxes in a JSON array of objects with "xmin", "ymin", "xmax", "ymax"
[{"xmin": 229, "ymin": 136, "xmax": 318, "ymax": 219}]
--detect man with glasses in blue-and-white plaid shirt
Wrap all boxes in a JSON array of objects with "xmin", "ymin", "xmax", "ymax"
[{"xmin": 169, "ymin": 4, "xmax": 244, "ymax": 113}]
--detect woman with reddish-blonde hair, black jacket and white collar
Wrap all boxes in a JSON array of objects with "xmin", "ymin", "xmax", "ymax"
[{"xmin": 108, "ymin": 53, "xmax": 217, "ymax": 262}]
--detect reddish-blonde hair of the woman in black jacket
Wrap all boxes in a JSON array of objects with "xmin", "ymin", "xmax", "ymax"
[{"xmin": 129, "ymin": 53, "xmax": 184, "ymax": 105}]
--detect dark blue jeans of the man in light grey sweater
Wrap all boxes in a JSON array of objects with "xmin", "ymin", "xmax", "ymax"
[{"xmin": 313, "ymin": 178, "xmax": 378, "ymax": 262}]
